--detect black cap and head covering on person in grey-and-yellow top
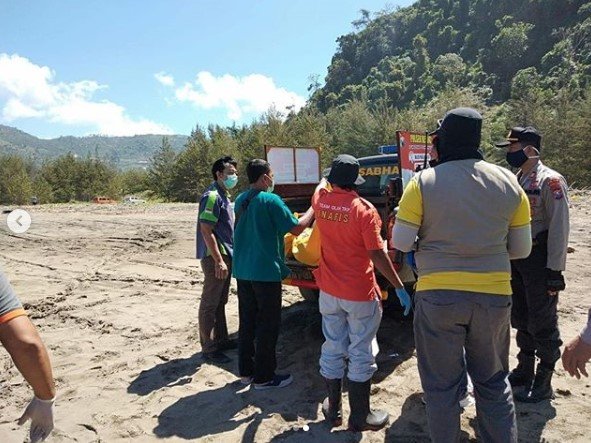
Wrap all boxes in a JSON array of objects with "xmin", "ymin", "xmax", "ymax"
[{"xmin": 435, "ymin": 108, "xmax": 483, "ymax": 163}]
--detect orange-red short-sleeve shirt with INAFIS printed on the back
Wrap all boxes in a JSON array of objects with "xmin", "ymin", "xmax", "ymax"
[{"xmin": 312, "ymin": 188, "xmax": 384, "ymax": 301}]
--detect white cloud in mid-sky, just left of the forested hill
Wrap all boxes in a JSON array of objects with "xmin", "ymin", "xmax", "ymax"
[{"xmin": 168, "ymin": 71, "xmax": 306, "ymax": 120}]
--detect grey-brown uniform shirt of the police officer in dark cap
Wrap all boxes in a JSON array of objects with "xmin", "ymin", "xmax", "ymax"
[{"xmin": 517, "ymin": 161, "xmax": 570, "ymax": 271}]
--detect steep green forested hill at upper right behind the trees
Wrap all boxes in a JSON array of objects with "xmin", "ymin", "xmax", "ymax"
[{"xmin": 310, "ymin": 0, "xmax": 591, "ymax": 112}]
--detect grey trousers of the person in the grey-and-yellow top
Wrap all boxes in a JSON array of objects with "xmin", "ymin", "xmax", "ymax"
[{"xmin": 414, "ymin": 290, "xmax": 517, "ymax": 443}]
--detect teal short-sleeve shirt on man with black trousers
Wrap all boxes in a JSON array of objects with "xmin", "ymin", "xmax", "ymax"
[{"xmin": 232, "ymin": 190, "xmax": 298, "ymax": 282}]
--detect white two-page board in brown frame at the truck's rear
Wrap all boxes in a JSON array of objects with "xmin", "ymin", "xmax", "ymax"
[{"xmin": 265, "ymin": 146, "xmax": 320, "ymax": 184}]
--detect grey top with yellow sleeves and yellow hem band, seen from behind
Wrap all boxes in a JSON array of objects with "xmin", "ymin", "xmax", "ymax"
[{"xmin": 394, "ymin": 160, "xmax": 530, "ymax": 295}]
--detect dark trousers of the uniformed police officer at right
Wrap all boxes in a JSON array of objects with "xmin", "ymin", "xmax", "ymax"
[{"xmin": 511, "ymin": 244, "xmax": 562, "ymax": 369}]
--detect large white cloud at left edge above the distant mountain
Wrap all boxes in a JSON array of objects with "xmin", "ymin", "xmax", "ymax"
[{"xmin": 0, "ymin": 54, "xmax": 172, "ymax": 135}]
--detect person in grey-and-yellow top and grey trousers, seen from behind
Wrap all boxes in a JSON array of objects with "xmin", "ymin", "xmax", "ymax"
[{"xmin": 393, "ymin": 108, "xmax": 531, "ymax": 442}]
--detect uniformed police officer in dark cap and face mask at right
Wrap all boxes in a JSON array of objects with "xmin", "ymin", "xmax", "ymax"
[{"xmin": 496, "ymin": 126, "xmax": 569, "ymax": 403}]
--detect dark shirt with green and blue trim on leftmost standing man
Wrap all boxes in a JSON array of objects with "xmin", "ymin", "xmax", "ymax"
[{"xmin": 196, "ymin": 182, "xmax": 234, "ymax": 259}]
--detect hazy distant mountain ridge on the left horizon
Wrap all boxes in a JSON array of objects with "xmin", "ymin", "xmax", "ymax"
[{"xmin": 0, "ymin": 125, "xmax": 187, "ymax": 169}]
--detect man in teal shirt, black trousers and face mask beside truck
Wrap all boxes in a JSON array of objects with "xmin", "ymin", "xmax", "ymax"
[{"xmin": 232, "ymin": 159, "xmax": 314, "ymax": 390}]
